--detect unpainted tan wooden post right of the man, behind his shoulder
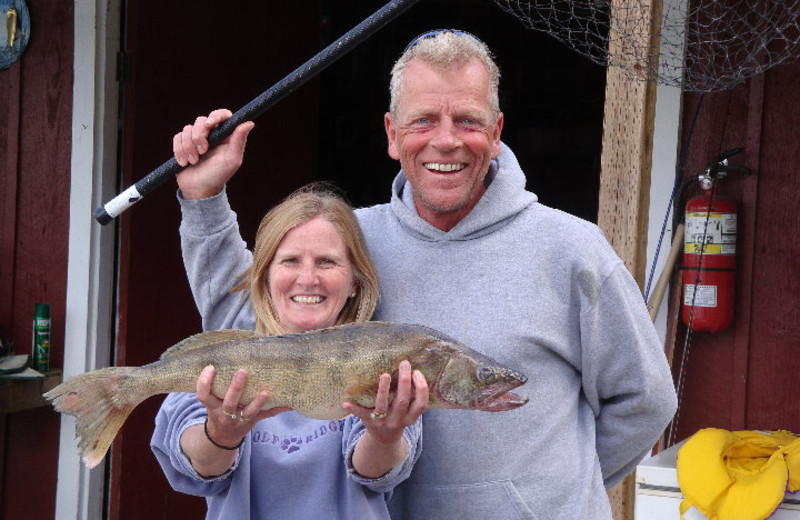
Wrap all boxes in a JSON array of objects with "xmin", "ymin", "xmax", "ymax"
[{"xmin": 597, "ymin": 0, "xmax": 660, "ymax": 520}]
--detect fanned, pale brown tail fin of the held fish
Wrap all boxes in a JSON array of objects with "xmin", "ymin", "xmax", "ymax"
[{"xmin": 44, "ymin": 367, "xmax": 150, "ymax": 468}]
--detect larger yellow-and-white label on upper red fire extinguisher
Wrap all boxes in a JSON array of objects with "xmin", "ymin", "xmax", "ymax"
[{"xmin": 684, "ymin": 212, "xmax": 736, "ymax": 255}]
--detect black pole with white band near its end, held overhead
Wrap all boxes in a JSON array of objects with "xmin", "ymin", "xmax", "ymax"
[{"xmin": 94, "ymin": 0, "xmax": 419, "ymax": 224}]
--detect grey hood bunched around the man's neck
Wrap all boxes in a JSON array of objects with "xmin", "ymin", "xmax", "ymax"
[{"xmin": 391, "ymin": 142, "xmax": 538, "ymax": 242}]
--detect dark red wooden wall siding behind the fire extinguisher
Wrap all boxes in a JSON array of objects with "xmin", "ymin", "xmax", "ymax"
[{"xmin": 674, "ymin": 59, "xmax": 800, "ymax": 441}]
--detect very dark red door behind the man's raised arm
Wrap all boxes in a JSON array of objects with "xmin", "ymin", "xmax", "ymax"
[{"xmin": 109, "ymin": 0, "xmax": 319, "ymax": 520}]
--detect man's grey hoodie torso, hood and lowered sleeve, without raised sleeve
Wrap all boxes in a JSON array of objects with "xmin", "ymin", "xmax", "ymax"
[{"xmin": 356, "ymin": 145, "xmax": 676, "ymax": 520}]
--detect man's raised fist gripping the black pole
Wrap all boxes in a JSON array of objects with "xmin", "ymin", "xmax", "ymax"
[{"xmin": 172, "ymin": 109, "xmax": 254, "ymax": 199}]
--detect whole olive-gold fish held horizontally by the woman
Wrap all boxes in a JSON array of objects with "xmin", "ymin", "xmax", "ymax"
[{"xmin": 44, "ymin": 321, "xmax": 528, "ymax": 468}]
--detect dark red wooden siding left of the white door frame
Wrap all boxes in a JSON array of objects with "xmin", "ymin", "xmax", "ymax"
[{"xmin": 0, "ymin": 0, "xmax": 73, "ymax": 519}]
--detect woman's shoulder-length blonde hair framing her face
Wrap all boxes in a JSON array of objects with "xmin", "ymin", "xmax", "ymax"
[{"xmin": 231, "ymin": 182, "xmax": 379, "ymax": 334}]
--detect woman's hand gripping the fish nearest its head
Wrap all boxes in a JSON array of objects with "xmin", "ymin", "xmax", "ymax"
[{"xmin": 342, "ymin": 361, "xmax": 428, "ymax": 478}]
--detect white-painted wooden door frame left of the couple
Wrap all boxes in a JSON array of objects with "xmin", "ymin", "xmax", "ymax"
[{"xmin": 55, "ymin": 0, "xmax": 121, "ymax": 520}]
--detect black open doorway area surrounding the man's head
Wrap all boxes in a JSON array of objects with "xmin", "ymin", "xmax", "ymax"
[{"xmin": 319, "ymin": 0, "xmax": 605, "ymax": 222}]
